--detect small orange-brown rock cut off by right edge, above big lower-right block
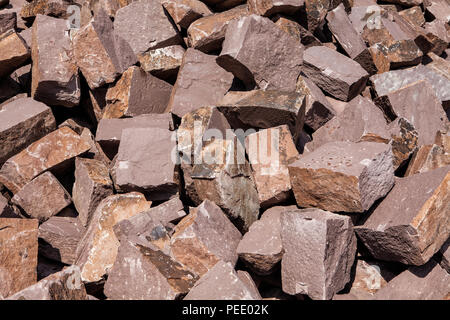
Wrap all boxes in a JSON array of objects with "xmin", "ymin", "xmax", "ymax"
[{"xmin": 405, "ymin": 131, "xmax": 450, "ymax": 177}]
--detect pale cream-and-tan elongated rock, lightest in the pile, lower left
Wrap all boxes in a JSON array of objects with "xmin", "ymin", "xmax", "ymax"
[{"xmin": 75, "ymin": 192, "xmax": 151, "ymax": 283}]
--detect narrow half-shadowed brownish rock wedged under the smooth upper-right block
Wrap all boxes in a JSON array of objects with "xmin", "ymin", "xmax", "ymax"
[{"xmin": 296, "ymin": 76, "xmax": 336, "ymax": 131}]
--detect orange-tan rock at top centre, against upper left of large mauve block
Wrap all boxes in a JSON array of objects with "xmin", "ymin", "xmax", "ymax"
[{"xmin": 187, "ymin": 5, "xmax": 249, "ymax": 52}]
